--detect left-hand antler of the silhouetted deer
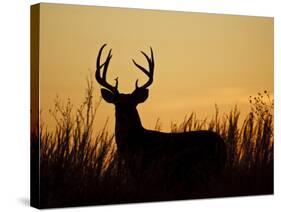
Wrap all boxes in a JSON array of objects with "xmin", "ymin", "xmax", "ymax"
[{"xmin": 96, "ymin": 44, "xmax": 118, "ymax": 93}]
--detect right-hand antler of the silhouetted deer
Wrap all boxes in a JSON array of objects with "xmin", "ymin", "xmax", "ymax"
[{"xmin": 133, "ymin": 47, "xmax": 154, "ymax": 89}]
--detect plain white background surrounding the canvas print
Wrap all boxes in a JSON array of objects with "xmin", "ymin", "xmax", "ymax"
[{"xmin": 0, "ymin": 0, "xmax": 281, "ymax": 212}]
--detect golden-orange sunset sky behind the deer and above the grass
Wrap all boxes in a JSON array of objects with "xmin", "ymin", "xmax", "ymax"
[{"xmin": 40, "ymin": 3, "xmax": 274, "ymax": 131}]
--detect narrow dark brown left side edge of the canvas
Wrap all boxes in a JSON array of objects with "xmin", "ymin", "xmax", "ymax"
[{"xmin": 30, "ymin": 4, "xmax": 41, "ymax": 208}]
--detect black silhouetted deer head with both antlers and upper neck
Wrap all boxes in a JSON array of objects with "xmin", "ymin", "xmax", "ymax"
[{"xmin": 95, "ymin": 44, "xmax": 154, "ymax": 131}]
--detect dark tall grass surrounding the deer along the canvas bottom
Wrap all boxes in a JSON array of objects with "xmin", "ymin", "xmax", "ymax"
[{"xmin": 31, "ymin": 80, "xmax": 273, "ymax": 208}]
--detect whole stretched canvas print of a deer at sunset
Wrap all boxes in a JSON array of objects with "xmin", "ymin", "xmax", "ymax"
[{"xmin": 31, "ymin": 3, "xmax": 274, "ymax": 208}]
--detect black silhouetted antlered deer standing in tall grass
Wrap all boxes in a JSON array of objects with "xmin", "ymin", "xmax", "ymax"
[{"xmin": 95, "ymin": 44, "xmax": 226, "ymax": 189}]
